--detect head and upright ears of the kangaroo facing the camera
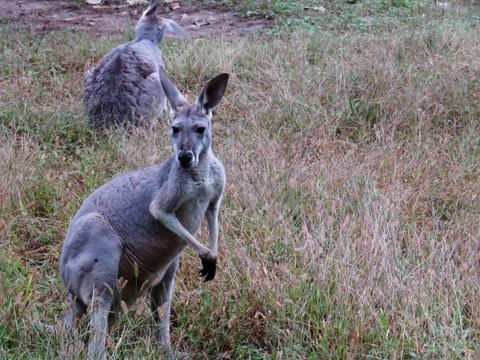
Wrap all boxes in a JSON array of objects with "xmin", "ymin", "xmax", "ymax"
[{"xmin": 160, "ymin": 68, "xmax": 228, "ymax": 169}]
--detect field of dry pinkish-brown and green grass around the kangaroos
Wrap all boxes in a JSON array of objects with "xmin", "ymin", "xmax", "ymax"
[{"xmin": 0, "ymin": 0, "xmax": 480, "ymax": 359}]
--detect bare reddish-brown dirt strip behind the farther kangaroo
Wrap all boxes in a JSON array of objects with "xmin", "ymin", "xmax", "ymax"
[{"xmin": 0, "ymin": 0, "xmax": 270, "ymax": 38}]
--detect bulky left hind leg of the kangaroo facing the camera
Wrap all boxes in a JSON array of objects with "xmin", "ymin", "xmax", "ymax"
[{"xmin": 61, "ymin": 213, "xmax": 122, "ymax": 359}]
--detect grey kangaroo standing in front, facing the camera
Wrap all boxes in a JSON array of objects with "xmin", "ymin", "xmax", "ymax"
[{"xmin": 60, "ymin": 69, "xmax": 228, "ymax": 359}]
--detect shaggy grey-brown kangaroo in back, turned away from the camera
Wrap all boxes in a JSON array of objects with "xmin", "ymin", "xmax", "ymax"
[{"xmin": 84, "ymin": 0, "xmax": 186, "ymax": 127}]
